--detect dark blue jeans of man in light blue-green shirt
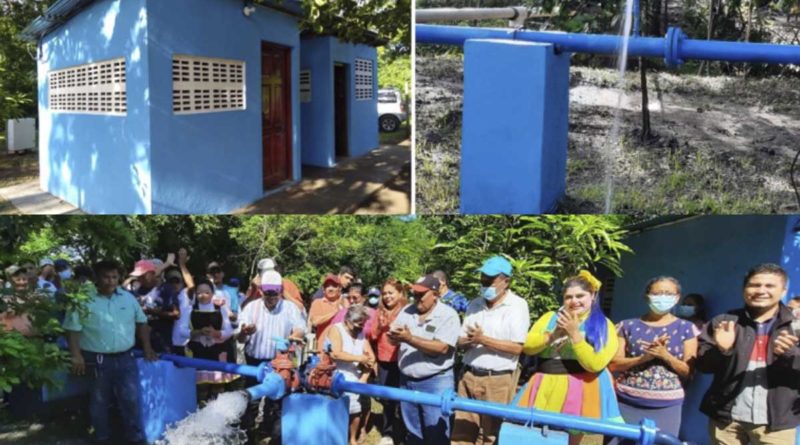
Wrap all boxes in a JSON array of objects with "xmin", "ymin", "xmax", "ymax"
[{"xmin": 83, "ymin": 351, "xmax": 144, "ymax": 442}]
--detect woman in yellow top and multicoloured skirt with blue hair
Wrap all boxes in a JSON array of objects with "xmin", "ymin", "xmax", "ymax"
[{"xmin": 518, "ymin": 271, "xmax": 623, "ymax": 444}]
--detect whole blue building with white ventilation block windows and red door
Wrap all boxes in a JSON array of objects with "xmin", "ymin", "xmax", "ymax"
[{"xmin": 23, "ymin": 0, "xmax": 378, "ymax": 213}]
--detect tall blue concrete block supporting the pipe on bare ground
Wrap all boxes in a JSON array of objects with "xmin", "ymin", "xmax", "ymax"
[{"xmin": 461, "ymin": 39, "xmax": 570, "ymax": 214}]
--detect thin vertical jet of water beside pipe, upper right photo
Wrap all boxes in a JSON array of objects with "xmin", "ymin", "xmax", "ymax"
[{"xmin": 605, "ymin": 0, "xmax": 634, "ymax": 213}]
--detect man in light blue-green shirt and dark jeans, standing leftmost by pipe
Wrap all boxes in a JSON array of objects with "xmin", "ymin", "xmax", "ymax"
[{"xmin": 63, "ymin": 261, "xmax": 157, "ymax": 443}]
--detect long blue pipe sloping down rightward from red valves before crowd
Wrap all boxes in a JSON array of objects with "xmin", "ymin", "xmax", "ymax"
[{"xmin": 331, "ymin": 373, "xmax": 681, "ymax": 445}]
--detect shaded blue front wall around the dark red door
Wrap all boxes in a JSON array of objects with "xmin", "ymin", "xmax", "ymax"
[{"xmin": 148, "ymin": 0, "xmax": 300, "ymax": 213}]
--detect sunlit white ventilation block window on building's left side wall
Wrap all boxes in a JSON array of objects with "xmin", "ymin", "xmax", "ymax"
[{"xmin": 48, "ymin": 58, "xmax": 128, "ymax": 116}]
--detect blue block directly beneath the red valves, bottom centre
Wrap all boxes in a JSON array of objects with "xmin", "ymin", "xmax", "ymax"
[{"xmin": 281, "ymin": 393, "xmax": 350, "ymax": 445}]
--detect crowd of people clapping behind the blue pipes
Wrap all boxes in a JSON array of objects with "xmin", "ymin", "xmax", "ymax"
[{"xmin": 0, "ymin": 253, "xmax": 800, "ymax": 445}]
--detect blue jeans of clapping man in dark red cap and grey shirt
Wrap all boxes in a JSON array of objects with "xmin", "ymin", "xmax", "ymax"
[{"xmin": 400, "ymin": 369, "xmax": 455, "ymax": 445}]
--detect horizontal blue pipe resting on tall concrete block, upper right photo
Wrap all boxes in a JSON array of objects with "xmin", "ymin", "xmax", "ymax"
[{"xmin": 415, "ymin": 24, "xmax": 800, "ymax": 66}]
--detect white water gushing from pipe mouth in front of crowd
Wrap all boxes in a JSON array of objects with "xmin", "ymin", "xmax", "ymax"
[{"xmin": 156, "ymin": 391, "xmax": 248, "ymax": 445}]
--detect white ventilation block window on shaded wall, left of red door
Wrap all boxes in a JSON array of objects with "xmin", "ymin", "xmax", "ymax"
[{"xmin": 172, "ymin": 55, "xmax": 245, "ymax": 114}]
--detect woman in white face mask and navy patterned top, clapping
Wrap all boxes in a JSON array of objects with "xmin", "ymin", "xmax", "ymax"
[{"xmin": 610, "ymin": 277, "xmax": 700, "ymax": 436}]
